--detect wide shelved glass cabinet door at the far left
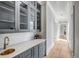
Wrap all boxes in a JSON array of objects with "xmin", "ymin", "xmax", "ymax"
[{"xmin": 0, "ymin": 1, "xmax": 15, "ymax": 30}]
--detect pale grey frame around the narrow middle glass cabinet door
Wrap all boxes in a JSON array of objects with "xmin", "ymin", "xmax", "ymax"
[{"xmin": 16, "ymin": 1, "xmax": 30, "ymax": 32}]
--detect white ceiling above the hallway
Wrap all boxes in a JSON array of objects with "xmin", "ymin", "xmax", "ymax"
[{"xmin": 49, "ymin": 1, "xmax": 72, "ymax": 21}]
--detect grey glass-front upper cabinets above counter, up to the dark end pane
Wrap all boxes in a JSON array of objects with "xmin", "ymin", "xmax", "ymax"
[{"xmin": 0, "ymin": 1, "xmax": 40, "ymax": 33}]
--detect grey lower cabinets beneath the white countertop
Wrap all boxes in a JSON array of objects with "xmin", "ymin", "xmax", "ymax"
[{"xmin": 14, "ymin": 42, "xmax": 46, "ymax": 58}]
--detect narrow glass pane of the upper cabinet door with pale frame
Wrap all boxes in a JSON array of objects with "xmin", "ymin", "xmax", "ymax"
[{"xmin": 20, "ymin": 2, "xmax": 28, "ymax": 30}]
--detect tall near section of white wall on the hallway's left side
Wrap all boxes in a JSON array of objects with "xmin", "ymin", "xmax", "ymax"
[{"xmin": 46, "ymin": 2, "xmax": 55, "ymax": 54}]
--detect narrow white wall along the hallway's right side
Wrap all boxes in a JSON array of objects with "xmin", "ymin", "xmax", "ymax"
[{"xmin": 68, "ymin": 15, "xmax": 73, "ymax": 51}]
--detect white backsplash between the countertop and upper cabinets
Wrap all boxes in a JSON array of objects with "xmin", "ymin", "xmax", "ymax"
[{"xmin": 0, "ymin": 32, "xmax": 34, "ymax": 49}]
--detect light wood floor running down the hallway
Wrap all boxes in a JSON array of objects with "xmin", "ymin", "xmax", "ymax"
[{"xmin": 47, "ymin": 39, "xmax": 71, "ymax": 58}]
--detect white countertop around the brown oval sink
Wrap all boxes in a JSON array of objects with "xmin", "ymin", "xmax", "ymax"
[{"xmin": 0, "ymin": 39, "xmax": 45, "ymax": 58}]
